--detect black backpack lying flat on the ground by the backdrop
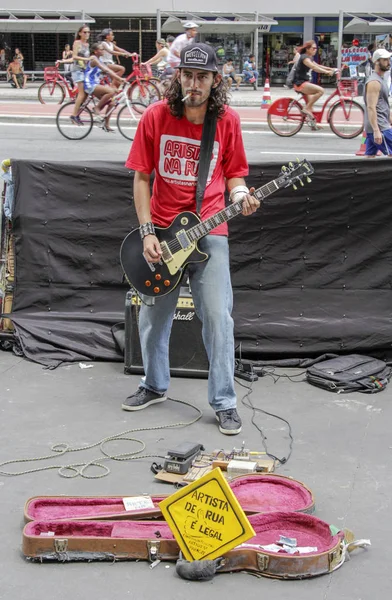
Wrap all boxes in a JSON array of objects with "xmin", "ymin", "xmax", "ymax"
[{"xmin": 306, "ymin": 354, "xmax": 392, "ymax": 394}]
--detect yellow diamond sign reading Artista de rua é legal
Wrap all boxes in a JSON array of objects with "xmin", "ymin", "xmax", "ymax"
[{"xmin": 159, "ymin": 468, "xmax": 256, "ymax": 560}]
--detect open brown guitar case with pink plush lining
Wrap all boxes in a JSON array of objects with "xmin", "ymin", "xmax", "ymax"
[{"xmin": 23, "ymin": 474, "xmax": 366, "ymax": 579}]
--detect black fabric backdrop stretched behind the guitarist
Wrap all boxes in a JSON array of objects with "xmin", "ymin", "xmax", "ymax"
[{"xmin": 6, "ymin": 159, "xmax": 392, "ymax": 366}]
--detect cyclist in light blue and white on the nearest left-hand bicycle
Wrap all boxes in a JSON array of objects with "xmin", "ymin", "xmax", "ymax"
[{"xmin": 81, "ymin": 42, "xmax": 124, "ymax": 132}]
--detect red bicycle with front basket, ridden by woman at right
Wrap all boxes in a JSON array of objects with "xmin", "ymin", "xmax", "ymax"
[{"xmin": 267, "ymin": 72, "xmax": 364, "ymax": 139}]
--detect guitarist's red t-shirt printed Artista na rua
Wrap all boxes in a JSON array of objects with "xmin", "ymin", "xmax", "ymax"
[{"xmin": 126, "ymin": 101, "xmax": 248, "ymax": 235}]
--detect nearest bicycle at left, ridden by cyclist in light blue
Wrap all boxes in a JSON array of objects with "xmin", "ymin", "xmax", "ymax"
[{"xmin": 56, "ymin": 82, "xmax": 146, "ymax": 142}]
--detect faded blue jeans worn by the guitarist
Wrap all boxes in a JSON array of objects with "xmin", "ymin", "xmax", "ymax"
[{"xmin": 139, "ymin": 235, "xmax": 237, "ymax": 411}]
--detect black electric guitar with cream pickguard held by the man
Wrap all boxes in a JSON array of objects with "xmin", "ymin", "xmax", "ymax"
[{"xmin": 120, "ymin": 160, "xmax": 314, "ymax": 297}]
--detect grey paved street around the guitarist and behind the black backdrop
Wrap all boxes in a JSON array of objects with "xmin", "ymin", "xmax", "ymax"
[{"xmin": 0, "ymin": 83, "xmax": 392, "ymax": 600}]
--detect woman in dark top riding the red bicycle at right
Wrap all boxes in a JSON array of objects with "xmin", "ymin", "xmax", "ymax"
[{"xmin": 293, "ymin": 40, "xmax": 336, "ymax": 129}]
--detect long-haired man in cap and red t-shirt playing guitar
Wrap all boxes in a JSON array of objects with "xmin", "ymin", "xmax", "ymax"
[{"xmin": 122, "ymin": 43, "xmax": 260, "ymax": 435}]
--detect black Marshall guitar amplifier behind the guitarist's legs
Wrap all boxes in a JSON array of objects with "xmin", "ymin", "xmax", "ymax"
[{"xmin": 124, "ymin": 287, "xmax": 208, "ymax": 378}]
